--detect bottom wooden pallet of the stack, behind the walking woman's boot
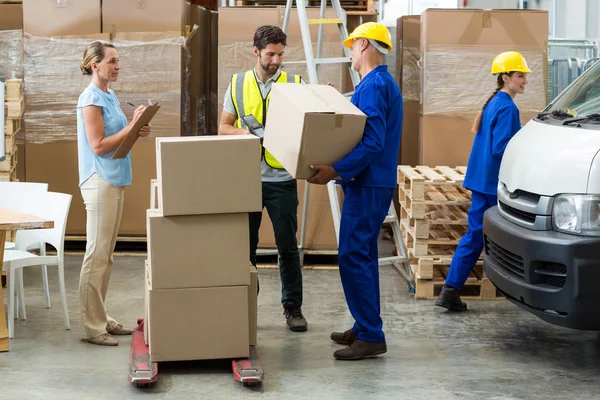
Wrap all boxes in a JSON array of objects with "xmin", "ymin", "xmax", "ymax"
[{"xmin": 415, "ymin": 262, "xmax": 504, "ymax": 300}]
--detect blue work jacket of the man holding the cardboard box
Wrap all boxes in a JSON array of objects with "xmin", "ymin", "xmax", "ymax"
[{"xmin": 333, "ymin": 65, "xmax": 403, "ymax": 188}]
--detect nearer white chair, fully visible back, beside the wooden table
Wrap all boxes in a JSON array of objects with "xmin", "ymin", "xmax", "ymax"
[{"xmin": 3, "ymin": 192, "xmax": 72, "ymax": 339}]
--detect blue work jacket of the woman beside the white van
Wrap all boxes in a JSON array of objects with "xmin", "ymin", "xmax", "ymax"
[{"xmin": 463, "ymin": 92, "xmax": 521, "ymax": 195}]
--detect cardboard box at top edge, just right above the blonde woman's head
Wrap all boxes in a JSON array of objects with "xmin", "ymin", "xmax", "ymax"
[{"xmin": 102, "ymin": 0, "xmax": 185, "ymax": 32}]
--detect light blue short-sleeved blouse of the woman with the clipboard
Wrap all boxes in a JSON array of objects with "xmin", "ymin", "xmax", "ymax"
[{"xmin": 77, "ymin": 82, "xmax": 131, "ymax": 187}]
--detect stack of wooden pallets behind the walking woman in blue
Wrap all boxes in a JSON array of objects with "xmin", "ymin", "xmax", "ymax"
[{"xmin": 398, "ymin": 166, "xmax": 499, "ymax": 300}]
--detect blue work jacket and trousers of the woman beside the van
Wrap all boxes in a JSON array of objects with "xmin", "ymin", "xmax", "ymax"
[{"xmin": 446, "ymin": 92, "xmax": 521, "ymax": 290}]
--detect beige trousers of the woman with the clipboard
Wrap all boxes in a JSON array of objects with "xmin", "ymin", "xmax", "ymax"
[{"xmin": 79, "ymin": 174, "xmax": 124, "ymax": 339}]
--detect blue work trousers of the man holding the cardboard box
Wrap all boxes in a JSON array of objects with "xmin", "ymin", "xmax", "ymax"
[{"xmin": 338, "ymin": 185, "xmax": 394, "ymax": 343}]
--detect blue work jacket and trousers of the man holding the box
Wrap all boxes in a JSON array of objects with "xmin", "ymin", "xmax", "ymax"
[{"xmin": 333, "ymin": 65, "xmax": 403, "ymax": 342}]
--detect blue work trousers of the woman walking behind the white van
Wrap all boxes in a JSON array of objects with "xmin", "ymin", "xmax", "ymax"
[{"xmin": 446, "ymin": 191, "xmax": 498, "ymax": 290}]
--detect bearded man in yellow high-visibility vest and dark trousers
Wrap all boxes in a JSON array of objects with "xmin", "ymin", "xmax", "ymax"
[{"xmin": 219, "ymin": 25, "xmax": 308, "ymax": 332}]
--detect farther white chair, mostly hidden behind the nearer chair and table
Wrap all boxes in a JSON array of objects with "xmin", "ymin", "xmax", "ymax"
[{"xmin": 0, "ymin": 182, "xmax": 50, "ymax": 308}]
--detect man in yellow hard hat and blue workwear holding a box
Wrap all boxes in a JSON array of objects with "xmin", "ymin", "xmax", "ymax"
[{"xmin": 308, "ymin": 22, "xmax": 403, "ymax": 360}]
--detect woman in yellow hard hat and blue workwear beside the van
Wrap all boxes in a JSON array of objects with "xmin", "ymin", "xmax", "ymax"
[{"xmin": 435, "ymin": 51, "xmax": 531, "ymax": 311}]
